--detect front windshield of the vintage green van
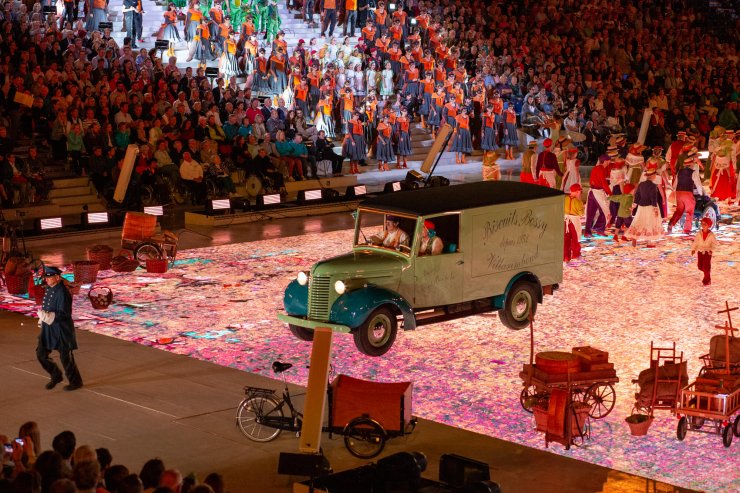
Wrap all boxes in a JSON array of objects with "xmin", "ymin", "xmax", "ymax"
[{"xmin": 355, "ymin": 209, "xmax": 416, "ymax": 255}]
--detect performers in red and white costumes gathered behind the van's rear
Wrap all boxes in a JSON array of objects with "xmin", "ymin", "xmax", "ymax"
[{"xmin": 556, "ymin": 127, "xmax": 740, "ymax": 285}]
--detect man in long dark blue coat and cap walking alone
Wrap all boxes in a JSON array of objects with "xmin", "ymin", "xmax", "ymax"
[{"xmin": 36, "ymin": 267, "xmax": 82, "ymax": 390}]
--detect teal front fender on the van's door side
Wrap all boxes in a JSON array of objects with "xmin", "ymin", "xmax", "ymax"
[{"xmin": 329, "ymin": 286, "xmax": 416, "ymax": 330}]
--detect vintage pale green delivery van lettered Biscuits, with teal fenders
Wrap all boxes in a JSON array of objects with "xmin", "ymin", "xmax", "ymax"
[{"xmin": 278, "ymin": 181, "xmax": 564, "ymax": 356}]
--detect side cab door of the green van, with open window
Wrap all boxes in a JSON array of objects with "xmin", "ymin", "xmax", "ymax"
[{"xmin": 413, "ymin": 213, "xmax": 465, "ymax": 308}]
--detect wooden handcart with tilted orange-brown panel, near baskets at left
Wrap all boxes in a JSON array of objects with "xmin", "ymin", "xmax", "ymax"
[{"xmin": 121, "ymin": 212, "xmax": 178, "ymax": 266}]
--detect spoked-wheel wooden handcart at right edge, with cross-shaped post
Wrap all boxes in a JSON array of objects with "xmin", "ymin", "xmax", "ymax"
[{"xmin": 673, "ymin": 304, "xmax": 740, "ymax": 447}]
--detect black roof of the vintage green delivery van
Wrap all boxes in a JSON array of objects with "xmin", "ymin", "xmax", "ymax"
[{"xmin": 360, "ymin": 181, "xmax": 564, "ymax": 216}]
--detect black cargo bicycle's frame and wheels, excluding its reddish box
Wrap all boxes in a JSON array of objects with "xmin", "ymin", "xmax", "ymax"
[{"xmin": 236, "ymin": 361, "xmax": 416, "ymax": 459}]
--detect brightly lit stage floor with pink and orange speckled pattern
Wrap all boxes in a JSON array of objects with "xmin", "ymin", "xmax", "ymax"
[{"xmin": 0, "ymin": 217, "xmax": 740, "ymax": 492}]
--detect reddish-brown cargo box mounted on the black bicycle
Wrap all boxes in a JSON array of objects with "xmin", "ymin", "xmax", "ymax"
[{"xmin": 331, "ymin": 375, "xmax": 413, "ymax": 432}]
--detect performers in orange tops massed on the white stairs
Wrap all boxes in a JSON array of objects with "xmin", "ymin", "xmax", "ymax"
[{"xmin": 153, "ymin": 0, "xmax": 519, "ymax": 172}]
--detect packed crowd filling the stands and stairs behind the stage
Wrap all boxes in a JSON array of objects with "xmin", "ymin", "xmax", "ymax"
[{"xmin": 0, "ymin": 0, "xmax": 740, "ymax": 206}]
